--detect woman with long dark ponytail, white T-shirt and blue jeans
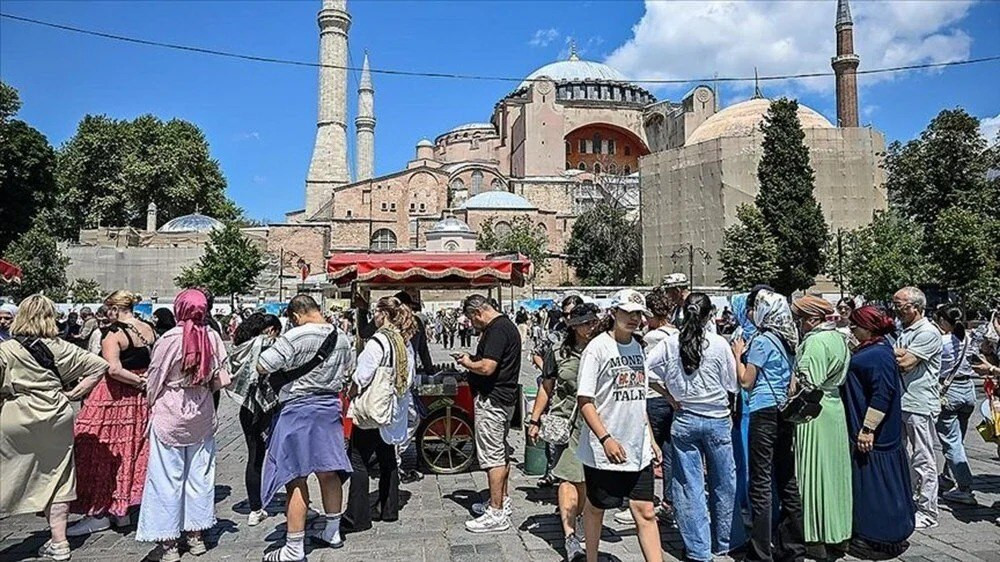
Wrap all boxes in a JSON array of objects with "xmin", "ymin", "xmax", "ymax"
[{"xmin": 646, "ymin": 293, "xmax": 743, "ymax": 560}]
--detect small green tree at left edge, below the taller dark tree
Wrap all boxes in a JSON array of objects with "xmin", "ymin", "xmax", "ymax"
[{"xmin": 6, "ymin": 220, "xmax": 69, "ymax": 301}]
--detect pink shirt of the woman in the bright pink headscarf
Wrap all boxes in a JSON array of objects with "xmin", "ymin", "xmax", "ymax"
[{"xmin": 147, "ymin": 326, "xmax": 232, "ymax": 447}]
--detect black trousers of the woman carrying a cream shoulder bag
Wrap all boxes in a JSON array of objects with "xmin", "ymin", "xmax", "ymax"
[{"xmin": 344, "ymin": 426, "xmax": 399, "ymax": 531}]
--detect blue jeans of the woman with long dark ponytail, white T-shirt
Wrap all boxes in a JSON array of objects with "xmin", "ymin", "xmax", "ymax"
[{"xmin": 670, "ymin": 410, "xmax": 742, "ymax": 560}]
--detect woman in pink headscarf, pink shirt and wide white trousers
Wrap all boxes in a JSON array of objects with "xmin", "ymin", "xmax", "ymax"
[{"xmin": 135, "ymin": 289, "xmax": 230, "ymax": 562}]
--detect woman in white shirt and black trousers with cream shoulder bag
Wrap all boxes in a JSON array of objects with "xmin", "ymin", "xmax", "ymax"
[{"xmin": 341, "ymin": 297, "xmax": 418, "ymax": 532}]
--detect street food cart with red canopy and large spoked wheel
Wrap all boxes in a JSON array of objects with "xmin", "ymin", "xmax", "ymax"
[{"xmin": 326, "ymin": 252, "xmax": 531, "ymax": 474}]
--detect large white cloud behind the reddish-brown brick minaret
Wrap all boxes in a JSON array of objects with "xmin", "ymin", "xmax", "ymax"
[{"xmin": 606, "ymin": 0, "xmax": 975, "ymax": 95}]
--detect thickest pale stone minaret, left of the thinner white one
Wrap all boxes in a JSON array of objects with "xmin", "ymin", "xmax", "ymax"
[{"xmin": 306, "ymin": 0, "xmax": 351, "ymax": 217}]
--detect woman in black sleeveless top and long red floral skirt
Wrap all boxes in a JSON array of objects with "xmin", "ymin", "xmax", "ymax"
[{"xmin": 66, "ymin": 291, "xmax": 156, "ymax": 537}]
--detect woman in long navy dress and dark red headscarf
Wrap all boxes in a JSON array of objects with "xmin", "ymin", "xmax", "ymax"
[{"xmin": 844, "ymin": 306, "xmax": 915, "ymax": 559}]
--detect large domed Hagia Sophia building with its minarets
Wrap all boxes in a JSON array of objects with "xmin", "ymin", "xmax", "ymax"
[{"xmin": 62, "ymin": 0, "xmax": 886, "ymax": 294}]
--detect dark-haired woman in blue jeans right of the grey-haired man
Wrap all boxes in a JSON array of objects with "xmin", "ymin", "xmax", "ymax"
[{"xmin": 935, "ymin": 304, "xmax": 978, "ymax": 505}]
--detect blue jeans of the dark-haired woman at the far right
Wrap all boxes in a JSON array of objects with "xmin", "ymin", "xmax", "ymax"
[{"xmin": 934, "ymin": 379, "xmax": 976, "ymax": 492}]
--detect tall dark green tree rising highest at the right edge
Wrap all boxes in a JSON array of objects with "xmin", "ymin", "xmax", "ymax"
[{"xmin": 885, "ymin": 109, "xmax": 1000, "ymax": 227}]
